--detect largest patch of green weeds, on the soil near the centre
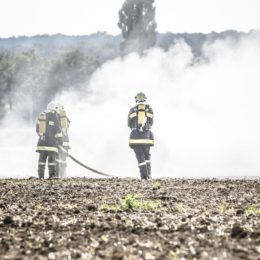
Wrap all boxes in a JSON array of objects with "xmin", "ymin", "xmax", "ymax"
[{"xmin": 101, "ymin": 194, "xmax": 160, "ymax": 211}]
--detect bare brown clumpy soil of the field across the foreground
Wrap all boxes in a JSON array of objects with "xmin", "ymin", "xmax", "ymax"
[{"xmin": 0, "ymin": 178, "xmax": 260, "ymax": 260}]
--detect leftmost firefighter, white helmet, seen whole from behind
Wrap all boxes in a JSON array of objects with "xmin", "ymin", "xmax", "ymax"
[{"xmin": 36, "ymin": 102, "xmax": 62, "ymax": 179}]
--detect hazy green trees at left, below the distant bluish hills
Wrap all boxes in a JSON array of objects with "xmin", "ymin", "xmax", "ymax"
[{"xmin": 0, "ymin": 49, "xmax": 100, "ymax": 120}]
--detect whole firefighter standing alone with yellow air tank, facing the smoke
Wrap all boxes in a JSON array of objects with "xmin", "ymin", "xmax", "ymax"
[{"xmin": 128, "ymin": 92, "xmax": 154, "ymax": 179}]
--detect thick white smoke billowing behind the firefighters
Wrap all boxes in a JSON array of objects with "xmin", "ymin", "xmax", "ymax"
[{"xmin": 0, "ymin": 34, "xmax": 260, "ymax": 177}]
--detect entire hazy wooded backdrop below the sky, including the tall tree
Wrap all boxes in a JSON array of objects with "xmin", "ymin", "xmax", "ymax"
[{"xmin": 0, "ymin": 0, "xmax": 260, "ymax": 121}]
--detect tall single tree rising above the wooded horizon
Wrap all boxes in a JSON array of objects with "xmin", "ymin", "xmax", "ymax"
[{"xmin": 118, "ymin": 0, "xmax": 157, "ymax": 54}]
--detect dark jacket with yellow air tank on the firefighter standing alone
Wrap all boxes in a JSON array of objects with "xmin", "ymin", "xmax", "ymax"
[{"xmin": 128, "ymin": 104, "xmax": 154, "ymax": 148}]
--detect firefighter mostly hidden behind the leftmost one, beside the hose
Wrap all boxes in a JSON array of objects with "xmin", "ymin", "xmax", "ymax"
[{"xmin": 58, "ymin": 105, "xmax": 70, "ymax": 178}]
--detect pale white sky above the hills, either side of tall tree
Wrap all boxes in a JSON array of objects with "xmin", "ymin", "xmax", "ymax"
[{"xmin": 0, "ymin": 0, "xmax": 260, "ymax": 37}]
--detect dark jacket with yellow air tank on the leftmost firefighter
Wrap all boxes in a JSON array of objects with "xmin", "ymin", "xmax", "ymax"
[{"xmin": 36, "ymin": 111, "xmax": 62, "ymax": 153}]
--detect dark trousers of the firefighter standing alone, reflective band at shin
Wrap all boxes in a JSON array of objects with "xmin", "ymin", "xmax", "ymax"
[{"xmin": 133, "ymin": 145, "xmax": 151, "ymax": 179}]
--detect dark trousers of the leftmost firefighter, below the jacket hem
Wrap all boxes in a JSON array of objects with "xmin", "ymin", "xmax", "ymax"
[{"xmin": 38, "ymin": 151, "xmax": 57, "ymax": 179}]
